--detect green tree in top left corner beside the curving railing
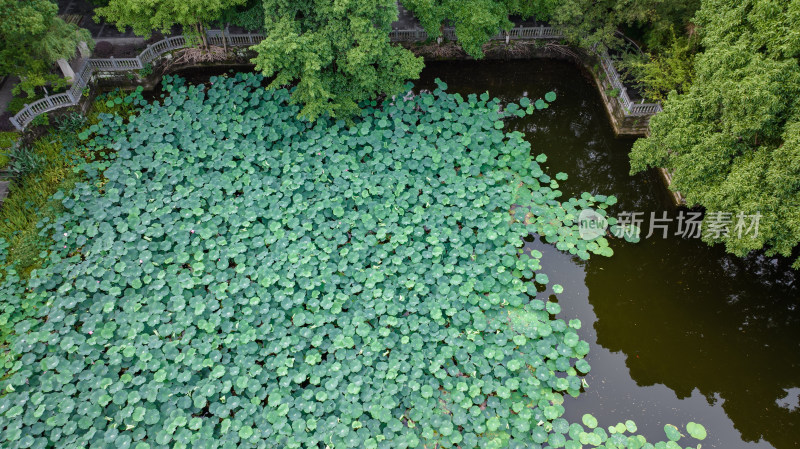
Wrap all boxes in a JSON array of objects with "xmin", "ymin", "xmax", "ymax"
[{"xmin": 0, "ymin": 0, "xmax": 93, "ymax": 97}]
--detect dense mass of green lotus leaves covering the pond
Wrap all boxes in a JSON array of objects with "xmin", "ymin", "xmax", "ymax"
[{"xmin": 0, "ymin": 74, "xmax": 705, "ymax": 449}]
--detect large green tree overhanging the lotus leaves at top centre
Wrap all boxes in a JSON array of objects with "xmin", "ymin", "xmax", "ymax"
[{"xmin": 253, "ymin": 0, "xmax": 423, "ymax": 120}]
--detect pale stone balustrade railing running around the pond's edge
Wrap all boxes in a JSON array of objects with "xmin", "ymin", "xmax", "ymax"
[{"xmin": 9, "ymin": 26, "xmax": 661, "ymax": 131}]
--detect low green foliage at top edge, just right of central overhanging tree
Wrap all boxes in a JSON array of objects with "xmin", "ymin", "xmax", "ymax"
[{"xmin": 403, "ymin": 0, "xmax": 558, "ymax": 58}]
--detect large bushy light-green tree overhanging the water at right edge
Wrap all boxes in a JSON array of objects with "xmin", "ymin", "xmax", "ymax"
[{"xmin": 631, "ymin": 0, "xmax": 800, "ymax": 268}]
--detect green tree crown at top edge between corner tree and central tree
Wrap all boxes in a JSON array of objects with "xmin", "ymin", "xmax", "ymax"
[{"xmin": 95, "ymin": 0, "xmax": 245, "ymax": 37}]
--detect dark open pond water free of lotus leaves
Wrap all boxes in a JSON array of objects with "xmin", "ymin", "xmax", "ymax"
[{"xmin": 417, "ymin": 60, "xmax": 800, "ymax": 449}]
